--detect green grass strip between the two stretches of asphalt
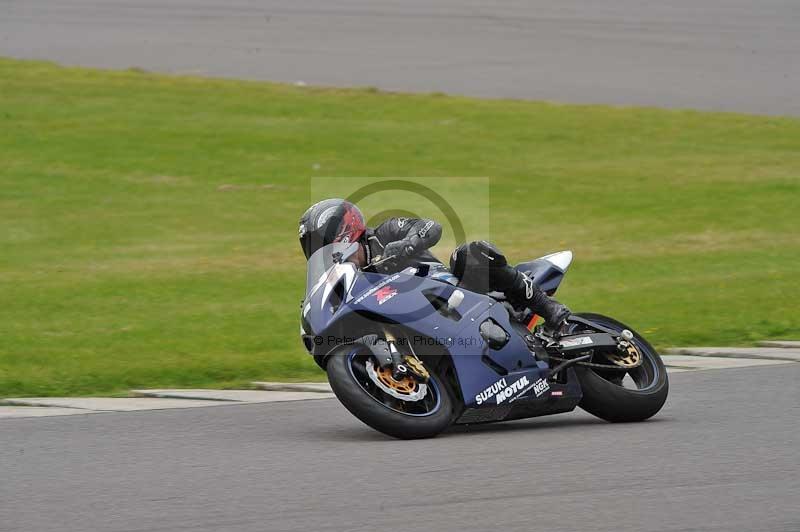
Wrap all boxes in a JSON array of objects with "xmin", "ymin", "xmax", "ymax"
[{"xmin": 0, "ymin": 59, "xmax": 800, "ymax": 396}]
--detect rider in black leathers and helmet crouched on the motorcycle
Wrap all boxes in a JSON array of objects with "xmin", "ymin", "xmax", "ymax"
[{"xmin": 300, "ymin": 198, "xmax": 570, "ymax": 331}]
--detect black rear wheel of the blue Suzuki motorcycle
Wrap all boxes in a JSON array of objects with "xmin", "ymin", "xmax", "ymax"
[{"xmin": 575, "ymin": 314, "xmax": 669, "ymax": 422}]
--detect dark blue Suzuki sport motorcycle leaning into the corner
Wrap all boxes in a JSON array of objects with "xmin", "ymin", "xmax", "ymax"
[{"xmin": 300, "ymin": 243, "xmax": 669, "ymax": 439}]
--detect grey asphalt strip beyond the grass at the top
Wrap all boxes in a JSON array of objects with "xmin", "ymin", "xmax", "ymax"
[{"xmin": 0, "ymin": 0, "xmax": 800, "ymax": 115}]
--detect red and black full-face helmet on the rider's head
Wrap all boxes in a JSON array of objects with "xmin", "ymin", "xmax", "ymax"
[{"xmin": 300, "ymin": 198, "xmax": 367, "ymax": 259}]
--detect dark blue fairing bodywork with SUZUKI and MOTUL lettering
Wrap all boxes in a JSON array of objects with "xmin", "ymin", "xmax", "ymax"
[{"xmin": 302, "ymin": 251, "xmax": 581, "ymax": 423}]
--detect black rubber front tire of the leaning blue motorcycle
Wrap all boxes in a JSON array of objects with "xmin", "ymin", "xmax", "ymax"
[{"xmin": 326, "ymin": 347, "xmax": 455, "ymax": 440}]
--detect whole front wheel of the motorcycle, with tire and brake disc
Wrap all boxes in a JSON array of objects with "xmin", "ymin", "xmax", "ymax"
[{"xmin": 326, "ymin": 346, "xmax": 455, "ymax": 440}]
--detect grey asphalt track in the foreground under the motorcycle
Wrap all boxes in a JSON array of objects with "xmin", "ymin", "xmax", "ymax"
[{"xmin": 0, "ymin": 364, "xmax": 800, "ymax": 532}]
